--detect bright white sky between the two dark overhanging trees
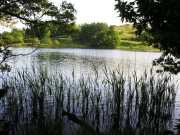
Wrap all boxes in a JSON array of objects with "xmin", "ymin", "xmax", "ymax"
[{"xmin": 50, "ymin": 0, "xmax": 121, "ymax": 25}]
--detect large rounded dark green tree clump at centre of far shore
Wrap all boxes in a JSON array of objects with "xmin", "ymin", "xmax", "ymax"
[{"xmin": 77, "ymin": 23, "xmax": 120, "ymax": 48}]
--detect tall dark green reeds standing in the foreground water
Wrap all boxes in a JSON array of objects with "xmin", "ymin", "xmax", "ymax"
[{"xmin": 1, "ymin": 68, "xmax": 176, "ymax": 135}]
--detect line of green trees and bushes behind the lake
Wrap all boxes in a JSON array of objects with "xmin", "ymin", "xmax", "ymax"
[{"xmin": 0, "ymin": 23, "xmax": 155, "ymax": 48}]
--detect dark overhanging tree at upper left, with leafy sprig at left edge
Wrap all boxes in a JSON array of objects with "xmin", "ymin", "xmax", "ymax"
[{"xmin": 0, "ymin": 0, "xmax": 75, "ymax": 71}]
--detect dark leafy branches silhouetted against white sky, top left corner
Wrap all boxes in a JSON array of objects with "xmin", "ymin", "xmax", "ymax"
[{"xmin": 0, "ymin": 0, "xmax": 75, "ymax": 23}]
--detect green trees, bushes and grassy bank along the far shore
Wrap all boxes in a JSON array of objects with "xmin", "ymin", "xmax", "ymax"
[{"xmin": 1, "ymin": 23, "xmax": 160, "ymax": 52}]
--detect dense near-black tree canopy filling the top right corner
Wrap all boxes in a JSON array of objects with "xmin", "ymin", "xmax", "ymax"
[{"xmin": 115, "ymin": 0, "xmax": 180, "ymax": 57}]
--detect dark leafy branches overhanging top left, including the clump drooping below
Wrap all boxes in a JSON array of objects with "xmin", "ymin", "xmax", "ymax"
[{"xmin": 0, "ymin": 0, "xmax": 76, "ymax": 40}]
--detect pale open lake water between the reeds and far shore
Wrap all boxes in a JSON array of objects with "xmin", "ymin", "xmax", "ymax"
[{"xmin": 3, "ymin": 48, "xmax": 180, "ymax": 132}]
